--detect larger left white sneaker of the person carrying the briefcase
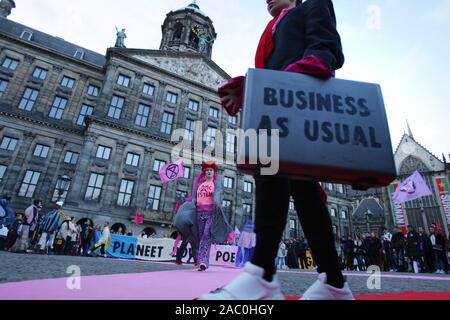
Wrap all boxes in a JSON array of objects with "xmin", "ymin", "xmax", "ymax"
[{"xmin": 200, "ymin": 262, "xmax": 284, "ymax": 300}]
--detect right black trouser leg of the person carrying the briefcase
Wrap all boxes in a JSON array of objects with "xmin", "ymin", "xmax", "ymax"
[{"xmin": 291, "ymin": 181, "xmax": 344, "ymax": 288}]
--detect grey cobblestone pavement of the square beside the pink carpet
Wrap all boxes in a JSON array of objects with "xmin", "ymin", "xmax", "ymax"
[{"xmin": 0, "ymin": 252, "xmax": 450, "ymax": 296}]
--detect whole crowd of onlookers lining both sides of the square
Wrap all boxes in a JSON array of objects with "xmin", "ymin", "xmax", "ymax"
[{"xmin": 0, "ymin": 193, "xmax": 450, "ymax": 274}]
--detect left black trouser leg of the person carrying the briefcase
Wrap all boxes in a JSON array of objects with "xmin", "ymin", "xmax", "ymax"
[{"xmin": 252, "ymin": 177, "xmax": 289, "ymax": 281}]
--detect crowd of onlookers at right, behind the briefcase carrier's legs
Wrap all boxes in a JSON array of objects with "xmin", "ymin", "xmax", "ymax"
[{"xmin": 276, "ymin": 223, "xmax": 450, "ymax": 274}]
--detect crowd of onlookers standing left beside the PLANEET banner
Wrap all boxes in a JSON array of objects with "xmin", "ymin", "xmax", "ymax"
[{"xmin": 0, "ymin": 192, "xmax": 152, "ymax": 257}]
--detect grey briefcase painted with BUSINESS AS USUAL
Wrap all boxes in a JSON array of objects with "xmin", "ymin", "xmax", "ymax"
[{"xmin": 237, "ymin": 69, "xmax": 396, "ymax": 190}]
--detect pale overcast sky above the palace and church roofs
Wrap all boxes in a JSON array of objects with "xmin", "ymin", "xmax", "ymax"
[{"xmin": 9, "ymin": 0, "xmax": 450, "ymax": 159}]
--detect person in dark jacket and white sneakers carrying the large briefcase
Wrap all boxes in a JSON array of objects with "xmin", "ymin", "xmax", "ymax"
[{"xmin": 202, "ymin": 0, "xmax": 353, "ymax": 299}]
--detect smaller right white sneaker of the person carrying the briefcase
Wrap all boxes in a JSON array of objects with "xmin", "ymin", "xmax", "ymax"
[{"xmin": 300, "ymin": 273, "xmax": 355, "ymax": 300}]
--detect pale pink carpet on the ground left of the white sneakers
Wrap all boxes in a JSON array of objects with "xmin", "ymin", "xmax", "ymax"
[{"xmin": 0, "ymin": 267, "xmax": 241, "ymax": 300}]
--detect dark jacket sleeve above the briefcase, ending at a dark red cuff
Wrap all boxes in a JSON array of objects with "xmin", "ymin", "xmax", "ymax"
[{"xmin": 304, "ymin": 0, "xmax": 344, "ymax": 70}]
